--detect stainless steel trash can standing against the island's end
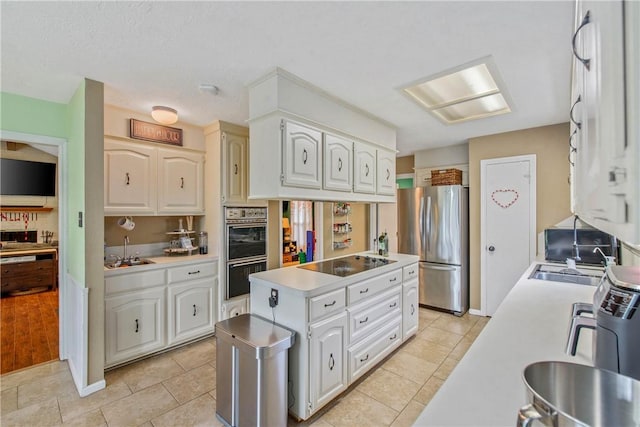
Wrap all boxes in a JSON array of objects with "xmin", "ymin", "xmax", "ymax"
[{"xmin": 216, "ymin": 314, "xmax": 295, "ymax": 427}]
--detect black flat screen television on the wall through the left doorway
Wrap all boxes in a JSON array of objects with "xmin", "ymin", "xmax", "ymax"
[{"xmin": 0, "ymin": 159, "xmax": 56, "ymax": 196}]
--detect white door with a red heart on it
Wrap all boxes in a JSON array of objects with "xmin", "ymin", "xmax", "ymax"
[{"xmin": 480, "ymin": 155, "xmax": 536, "ymax": 316}]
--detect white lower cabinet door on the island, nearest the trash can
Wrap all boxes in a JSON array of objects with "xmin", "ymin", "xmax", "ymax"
[{"xmin": 309, "ymin": 312, "xmax": 347, "ymax": 411}]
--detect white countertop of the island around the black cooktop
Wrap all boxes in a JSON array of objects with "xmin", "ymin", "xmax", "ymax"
[{"xmin": 249, "ymin": 252, "xmax": 418, "ymax": 297}]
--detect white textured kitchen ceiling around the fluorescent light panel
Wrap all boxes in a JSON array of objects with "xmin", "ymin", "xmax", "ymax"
[{"xmin": 0, "ymin": 0, "xmax": 573, "ymax": 155}]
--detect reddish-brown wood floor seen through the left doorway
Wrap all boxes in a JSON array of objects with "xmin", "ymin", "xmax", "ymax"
[{"xmin": 0, "ymin": 289, "xmax": 59, "ymax": 374}]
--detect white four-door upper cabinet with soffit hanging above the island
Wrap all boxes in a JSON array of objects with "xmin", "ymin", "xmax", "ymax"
[{"xmin": 248, "ymin": 69, "xmax": 396, "ymax": 203}]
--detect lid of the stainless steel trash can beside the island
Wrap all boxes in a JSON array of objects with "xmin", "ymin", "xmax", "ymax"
[{"xmin": 216, "ymin": 314, "xmax": 295, "ymax": 359}]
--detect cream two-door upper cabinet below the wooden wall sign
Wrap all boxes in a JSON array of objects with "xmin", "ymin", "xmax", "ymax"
[{"xmin": 104, "ymin": 138, "xmax": 204, "ymax": 215}]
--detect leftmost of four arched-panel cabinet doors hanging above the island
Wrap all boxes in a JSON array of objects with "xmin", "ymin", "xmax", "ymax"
[{"xmin": 282, "ymin": 120, "xmax": 322, "ymax": 188}]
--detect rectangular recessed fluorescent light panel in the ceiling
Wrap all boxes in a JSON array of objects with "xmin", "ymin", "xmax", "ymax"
[{"xmin": 400, "ymin": 57, "xmax": 511, "ymax": 124}]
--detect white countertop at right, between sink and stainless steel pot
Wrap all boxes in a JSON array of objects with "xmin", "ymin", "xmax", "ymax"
[{"xmin": 414, "ymin": 262, "xmax": 596, "ymax": 427}]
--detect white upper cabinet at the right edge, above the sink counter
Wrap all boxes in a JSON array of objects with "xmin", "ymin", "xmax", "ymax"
[{"xmin": 569, "ymin": 1, "xmax": 640, "ymax": 244}]
